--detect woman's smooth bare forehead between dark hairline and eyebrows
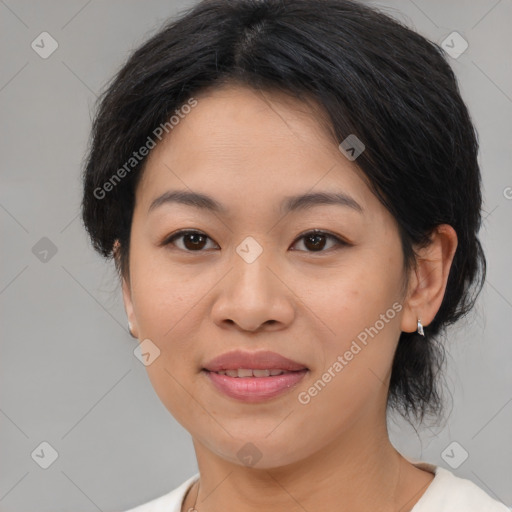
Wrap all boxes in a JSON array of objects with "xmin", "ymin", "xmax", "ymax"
[{"xmin": 137, "ymin": 85, "xmax": 371, "ymax": 214}]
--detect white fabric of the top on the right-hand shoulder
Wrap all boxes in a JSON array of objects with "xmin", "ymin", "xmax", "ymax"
[{"xmin": 411, "ymin": 463, "xmax": 510, "ymax": 512}]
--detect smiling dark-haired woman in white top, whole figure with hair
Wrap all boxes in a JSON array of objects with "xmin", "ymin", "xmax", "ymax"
[{"xmin": 83, "ymin": 0, "xmax": 508, "ymax": 512}]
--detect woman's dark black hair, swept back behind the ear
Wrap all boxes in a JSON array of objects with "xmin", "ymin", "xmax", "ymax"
[{"xmin": 82, "ymin": 0, "xmax": 486, "ymax": 421}]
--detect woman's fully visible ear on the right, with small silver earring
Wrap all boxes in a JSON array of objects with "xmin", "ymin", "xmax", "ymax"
[{"xmin": 401, "ymin": 224, "xmax": 457, "ymax": 332}]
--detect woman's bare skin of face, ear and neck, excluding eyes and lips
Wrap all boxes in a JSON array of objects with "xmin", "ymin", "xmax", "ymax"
[{"xmin": 119, "ymin": 85, "xmax": 457, "ymax": 512}]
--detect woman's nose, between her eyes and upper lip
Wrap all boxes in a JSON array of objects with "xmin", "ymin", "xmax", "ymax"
[{"xmin": 212, "ymin": 244, "xmax": 295, "ymax": 332}]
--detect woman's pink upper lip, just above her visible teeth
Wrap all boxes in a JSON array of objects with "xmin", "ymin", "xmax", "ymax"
[{"xmin": 203, "ymin": 350, "xmax": 308, "ymax": 372}]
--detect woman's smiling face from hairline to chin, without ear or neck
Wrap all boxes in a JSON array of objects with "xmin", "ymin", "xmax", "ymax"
[{"xmin": 123, "ymin": 86, "xmax": 412, "ymax": 467}]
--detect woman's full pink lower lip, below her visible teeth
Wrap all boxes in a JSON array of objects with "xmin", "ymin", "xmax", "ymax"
[{"xmin": 203, "ymin": 369, "xmax": 308, "ymax": 402}]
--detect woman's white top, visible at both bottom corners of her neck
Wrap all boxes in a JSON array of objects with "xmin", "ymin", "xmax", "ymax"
[{"xmin": 125, "ymin": 461, "xmax": 512, "ymax": 512}]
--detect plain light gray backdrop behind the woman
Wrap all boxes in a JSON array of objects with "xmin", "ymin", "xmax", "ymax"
[{"xmin": 0, "ymin": 0, "xmax": 512, "ymax": 512}]
